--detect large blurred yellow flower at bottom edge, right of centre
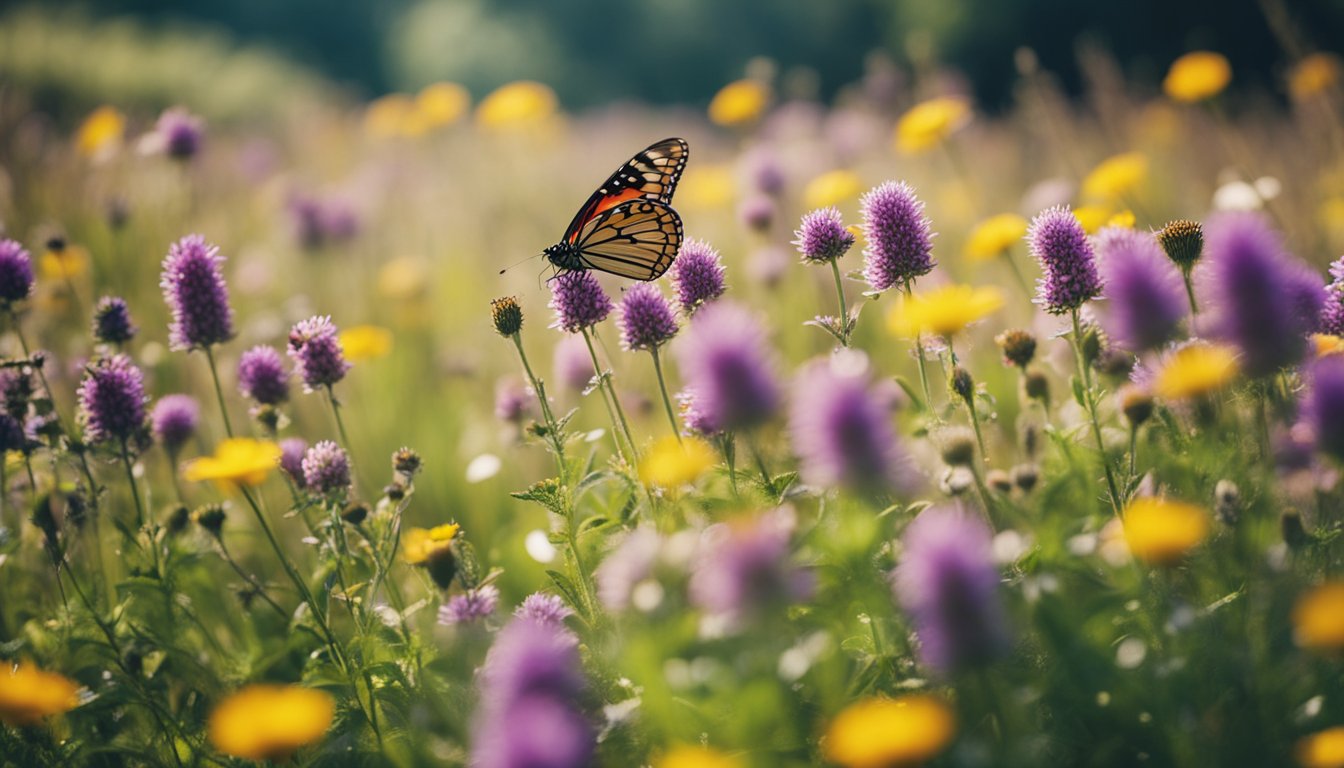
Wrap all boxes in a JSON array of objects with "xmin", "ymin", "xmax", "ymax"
[{"xmin": 821, "ymin": 694, "xmax": 957, "ymax": 768}]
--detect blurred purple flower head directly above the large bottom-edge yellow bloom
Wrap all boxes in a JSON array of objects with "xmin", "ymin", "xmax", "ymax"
[{"xmin": 892, "ymin": 507, "xmax": 1008, "ymax": 674}]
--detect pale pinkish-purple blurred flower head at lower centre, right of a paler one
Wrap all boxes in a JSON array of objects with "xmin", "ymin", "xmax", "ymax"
[{"xmin": 689, "ymin": 507, "xmax": 813, "ymax": 624}]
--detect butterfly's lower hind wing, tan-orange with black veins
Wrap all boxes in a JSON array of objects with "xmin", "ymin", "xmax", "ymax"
[{"xmin": 574, "ymin": 200, "xmax": 681, "ymax": 280}]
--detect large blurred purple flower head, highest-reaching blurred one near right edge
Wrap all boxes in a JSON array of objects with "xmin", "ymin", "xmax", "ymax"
[{"xmin": 1204, "ymin": 213, "xmax": 1325, "ymax": 377}]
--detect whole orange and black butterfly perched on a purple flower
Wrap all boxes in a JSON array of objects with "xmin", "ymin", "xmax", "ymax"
[{"xmin": 546, "ymin": 139, "xmax": 691, "ymax": 280}]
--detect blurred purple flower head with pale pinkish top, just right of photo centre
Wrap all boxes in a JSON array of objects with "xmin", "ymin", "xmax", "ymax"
[{"xmin": 789, "ymin": 352, "xmax": 909, "ymax": 494}]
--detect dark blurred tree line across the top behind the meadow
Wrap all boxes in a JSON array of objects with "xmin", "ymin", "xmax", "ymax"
[{"xmin": 0, "ymin": 0, "xmax": 1344, "ymax": 117}]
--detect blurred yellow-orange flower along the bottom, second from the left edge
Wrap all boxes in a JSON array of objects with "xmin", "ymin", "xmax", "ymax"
[{"xmin": 210, "ymin": 685, "xmax": 336, "ymax": 761}]
